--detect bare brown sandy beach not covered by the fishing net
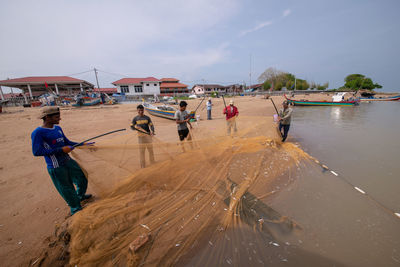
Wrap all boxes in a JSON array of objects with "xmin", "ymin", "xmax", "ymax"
[{"xmin": 0, "ymin": 97, "xmax": 283, "ymax": 266}]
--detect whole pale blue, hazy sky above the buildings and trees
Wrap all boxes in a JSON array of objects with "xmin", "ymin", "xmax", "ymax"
[{"xmin": 0, "ymin": 0, "xmax": 400, "ymax": 91}]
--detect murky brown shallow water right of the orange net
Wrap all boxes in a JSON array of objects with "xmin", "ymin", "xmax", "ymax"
[{"xmin": 274, "ymin": 102, "xmax": 400, "ymax": 266}]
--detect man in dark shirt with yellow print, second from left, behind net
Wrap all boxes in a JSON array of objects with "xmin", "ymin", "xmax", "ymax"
[{"xmin": 131, "ymin": 105, "xmax": 155, "ymax": 168}]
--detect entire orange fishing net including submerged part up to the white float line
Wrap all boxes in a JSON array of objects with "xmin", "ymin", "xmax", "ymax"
[{"xmin": 36, "ymin": 101, "xmax": 400, "ymax": 266}]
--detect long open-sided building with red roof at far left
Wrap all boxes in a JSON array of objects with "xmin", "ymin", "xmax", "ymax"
[{"xmin": 0, "ymin": 76, "xmax": 94, "ymax": 102}]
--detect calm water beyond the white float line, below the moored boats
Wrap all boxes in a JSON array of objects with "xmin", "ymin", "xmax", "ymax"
[{"xmin": 290, "ymin": 102, "xmax": 400, "ymax": 212}]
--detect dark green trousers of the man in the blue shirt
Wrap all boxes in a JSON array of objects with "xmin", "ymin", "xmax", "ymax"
[{"xmin": 47, "ymin": 159, "xmax": 88, "ymax": 214}]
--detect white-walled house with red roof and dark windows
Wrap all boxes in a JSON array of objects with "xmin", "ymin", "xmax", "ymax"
[{"xmin": 112, "ymin": 77, "xmax": 161, "ymax": 96}]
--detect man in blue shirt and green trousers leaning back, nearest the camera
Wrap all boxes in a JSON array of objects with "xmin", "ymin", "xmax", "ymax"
[{"xmin": 31, "ymin": 106, "xmax": 93, "ymax": 215}]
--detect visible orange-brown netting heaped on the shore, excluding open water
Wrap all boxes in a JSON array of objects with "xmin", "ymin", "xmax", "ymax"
[{"xmin": 69, "ymin": 117, "xmax": 307, "ymax": 266}]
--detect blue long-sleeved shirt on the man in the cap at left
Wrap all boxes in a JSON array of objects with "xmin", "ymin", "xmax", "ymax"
[{"xmin": 31, "ymin": 125, "xmax": 77, "ymax": 169}]
